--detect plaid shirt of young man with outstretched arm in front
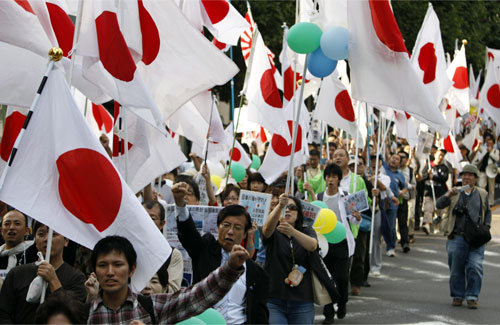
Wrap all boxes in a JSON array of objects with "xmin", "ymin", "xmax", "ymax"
[{"xmin": 87, "ymin": 263, "xmax": 243, "ymax": 324}]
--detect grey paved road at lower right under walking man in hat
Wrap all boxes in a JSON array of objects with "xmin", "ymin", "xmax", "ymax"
[{"xmin": 315, "ymin": 208, "xmax": 500, "ymax": 324}]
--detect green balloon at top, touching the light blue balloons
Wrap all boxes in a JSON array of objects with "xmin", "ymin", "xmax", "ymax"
[{"xmin": 286, "ymin": 22, "xmax": 323, "ymax": 54}]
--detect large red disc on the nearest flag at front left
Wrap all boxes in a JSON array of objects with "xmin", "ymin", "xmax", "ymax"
[{"xmin": 56, "ymin": 148, "xmax": 122, "ymax": 232}]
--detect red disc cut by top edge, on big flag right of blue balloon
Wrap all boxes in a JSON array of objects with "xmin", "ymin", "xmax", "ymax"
[{"xmin": 369, "ymin": 0, "xmax": 408, "ymax": 53}]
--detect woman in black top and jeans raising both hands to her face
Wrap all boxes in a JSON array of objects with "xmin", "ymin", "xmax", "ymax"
[{"xmin": 262, "ymin": 194, "xmax": 318, "ymax": 324}]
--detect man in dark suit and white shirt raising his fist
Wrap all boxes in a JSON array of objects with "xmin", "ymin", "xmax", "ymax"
[{"xmin": 172, "ymin": 182, "xmax": 269, "ymax": 324}]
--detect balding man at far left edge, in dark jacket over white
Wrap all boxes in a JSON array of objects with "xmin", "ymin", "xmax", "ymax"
[{"xmin": 0, "ymin": 210, "xmax": 37, "ymax": 279}]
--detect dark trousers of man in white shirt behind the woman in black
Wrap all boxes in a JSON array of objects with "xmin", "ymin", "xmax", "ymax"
[{"xmin": 323, "ymin": 239, "xmax": 349, "ymax": 317}]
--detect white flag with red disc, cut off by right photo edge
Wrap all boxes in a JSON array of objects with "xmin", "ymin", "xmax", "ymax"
[{"xmin": 479, "ymin": 60, "xmax": 500, "ymax": 124}]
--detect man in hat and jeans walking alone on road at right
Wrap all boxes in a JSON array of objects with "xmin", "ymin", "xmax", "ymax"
[{"xmin": 436, "ymin": 164, "xmax": 491, "ymax": 309}]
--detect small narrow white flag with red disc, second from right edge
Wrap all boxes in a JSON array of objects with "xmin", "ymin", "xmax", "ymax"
[{"xmin": 446, "ymin": 45, "xmax": 470, "ymax": 115}]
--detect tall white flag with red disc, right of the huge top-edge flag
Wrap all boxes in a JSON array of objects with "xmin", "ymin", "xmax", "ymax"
[{"xmin": 411, "ymin": 2, "xmax": 451, "ymax": 105}]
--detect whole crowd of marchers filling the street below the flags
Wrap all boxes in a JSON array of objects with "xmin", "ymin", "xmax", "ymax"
[{"xmin": 0, "ymin": 121, "xmax": 494, "ymax": 324}]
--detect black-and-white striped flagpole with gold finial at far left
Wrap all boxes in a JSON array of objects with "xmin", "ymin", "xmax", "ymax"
[{"xmin": 0, "ymin": 47, "xmax": 63, "ymax": 187}]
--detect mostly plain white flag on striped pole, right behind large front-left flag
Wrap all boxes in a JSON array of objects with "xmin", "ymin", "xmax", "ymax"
[{"xmin": 113, "ymin": 107, "xmax": 187, "ymax": 193}]
